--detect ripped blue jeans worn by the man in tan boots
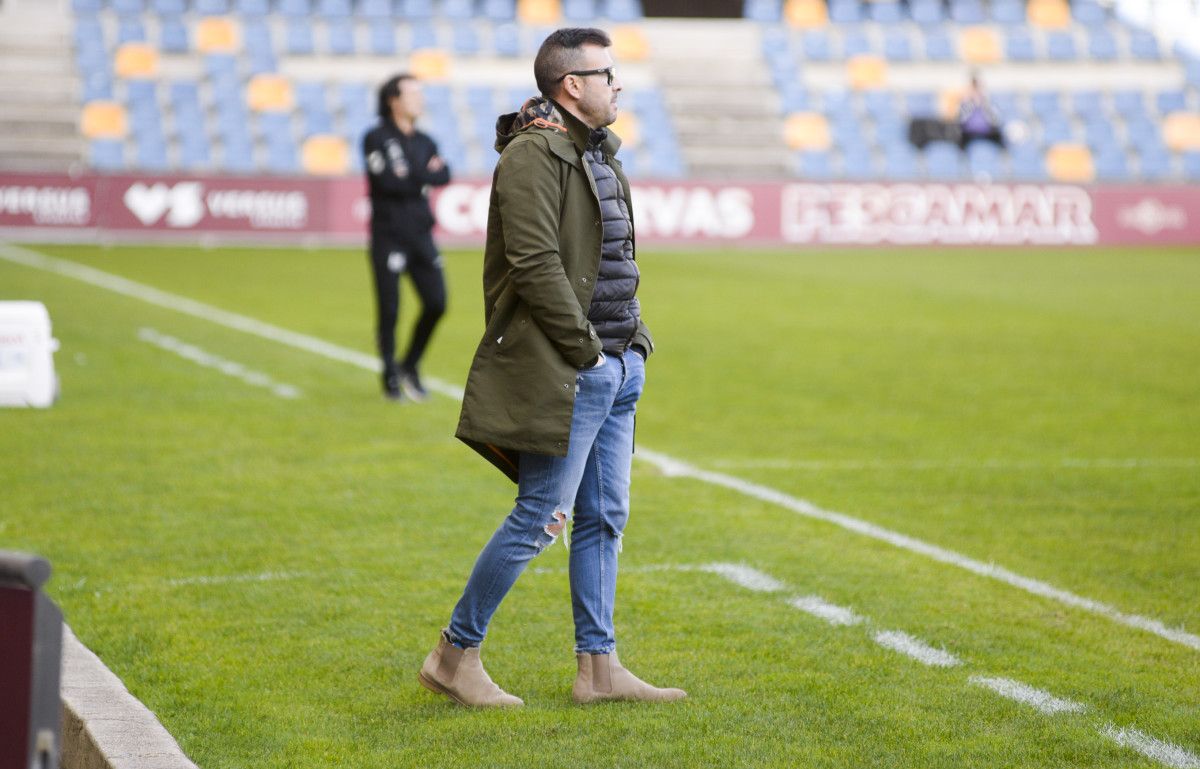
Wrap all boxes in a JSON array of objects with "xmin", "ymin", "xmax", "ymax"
[{"xmin": 446, "ymin": 350, "xmax": 646, "ymax": 654}]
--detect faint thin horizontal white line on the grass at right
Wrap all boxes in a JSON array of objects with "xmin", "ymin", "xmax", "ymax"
[{"xmin": 709, "ymin": 457, "xmax": 1200, "ymax": 470}]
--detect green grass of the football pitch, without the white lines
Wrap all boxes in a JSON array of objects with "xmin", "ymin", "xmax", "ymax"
[{"xmin": 0, "ymin": 246, "xmax": 1200, "ymax": 769}]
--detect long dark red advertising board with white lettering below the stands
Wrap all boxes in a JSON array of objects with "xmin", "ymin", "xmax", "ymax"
[{"xmin": 0, "ymin": 175, "xmax": 1200, "ymax": 246}]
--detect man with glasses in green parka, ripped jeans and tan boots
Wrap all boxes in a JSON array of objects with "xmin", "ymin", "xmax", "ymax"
[{"xmin": 419, "ymin": 29, "xmax": 686, "ymax": 707}]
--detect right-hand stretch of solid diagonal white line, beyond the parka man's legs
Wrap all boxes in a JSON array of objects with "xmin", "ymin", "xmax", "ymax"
[{"xmin": 634, "ymin": 446, "xmax": 1200, "ymax": 650}]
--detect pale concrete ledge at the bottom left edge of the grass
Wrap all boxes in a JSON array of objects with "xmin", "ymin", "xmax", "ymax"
[{"xmin": 61, "ymin": 625, "xmax": 198, "ymax": 769}]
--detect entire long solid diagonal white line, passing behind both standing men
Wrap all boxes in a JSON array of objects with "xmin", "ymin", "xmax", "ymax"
[{"xmin": 0, "ymin": 244, "xmax": 1200, "ymax": 650}]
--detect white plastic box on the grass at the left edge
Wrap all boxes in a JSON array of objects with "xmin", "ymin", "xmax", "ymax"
[{"xmin": 0, "ymin": 301, "xmax": 59, "ymax": 408}]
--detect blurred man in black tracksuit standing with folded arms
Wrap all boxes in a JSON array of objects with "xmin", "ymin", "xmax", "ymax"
[{"xmin": 362, "ymin": 74, "xmax": 450, "ymax": 401}]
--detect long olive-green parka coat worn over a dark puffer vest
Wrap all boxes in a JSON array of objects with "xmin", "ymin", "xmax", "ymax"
[{"xmin": 455, "ymin": 97, "xmax": 654, "ymax": 481}]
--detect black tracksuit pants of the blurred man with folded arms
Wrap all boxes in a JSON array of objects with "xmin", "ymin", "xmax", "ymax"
[{"xmin": 371, "ymin": 226, "xmax": 446, "ymax": 373}]
